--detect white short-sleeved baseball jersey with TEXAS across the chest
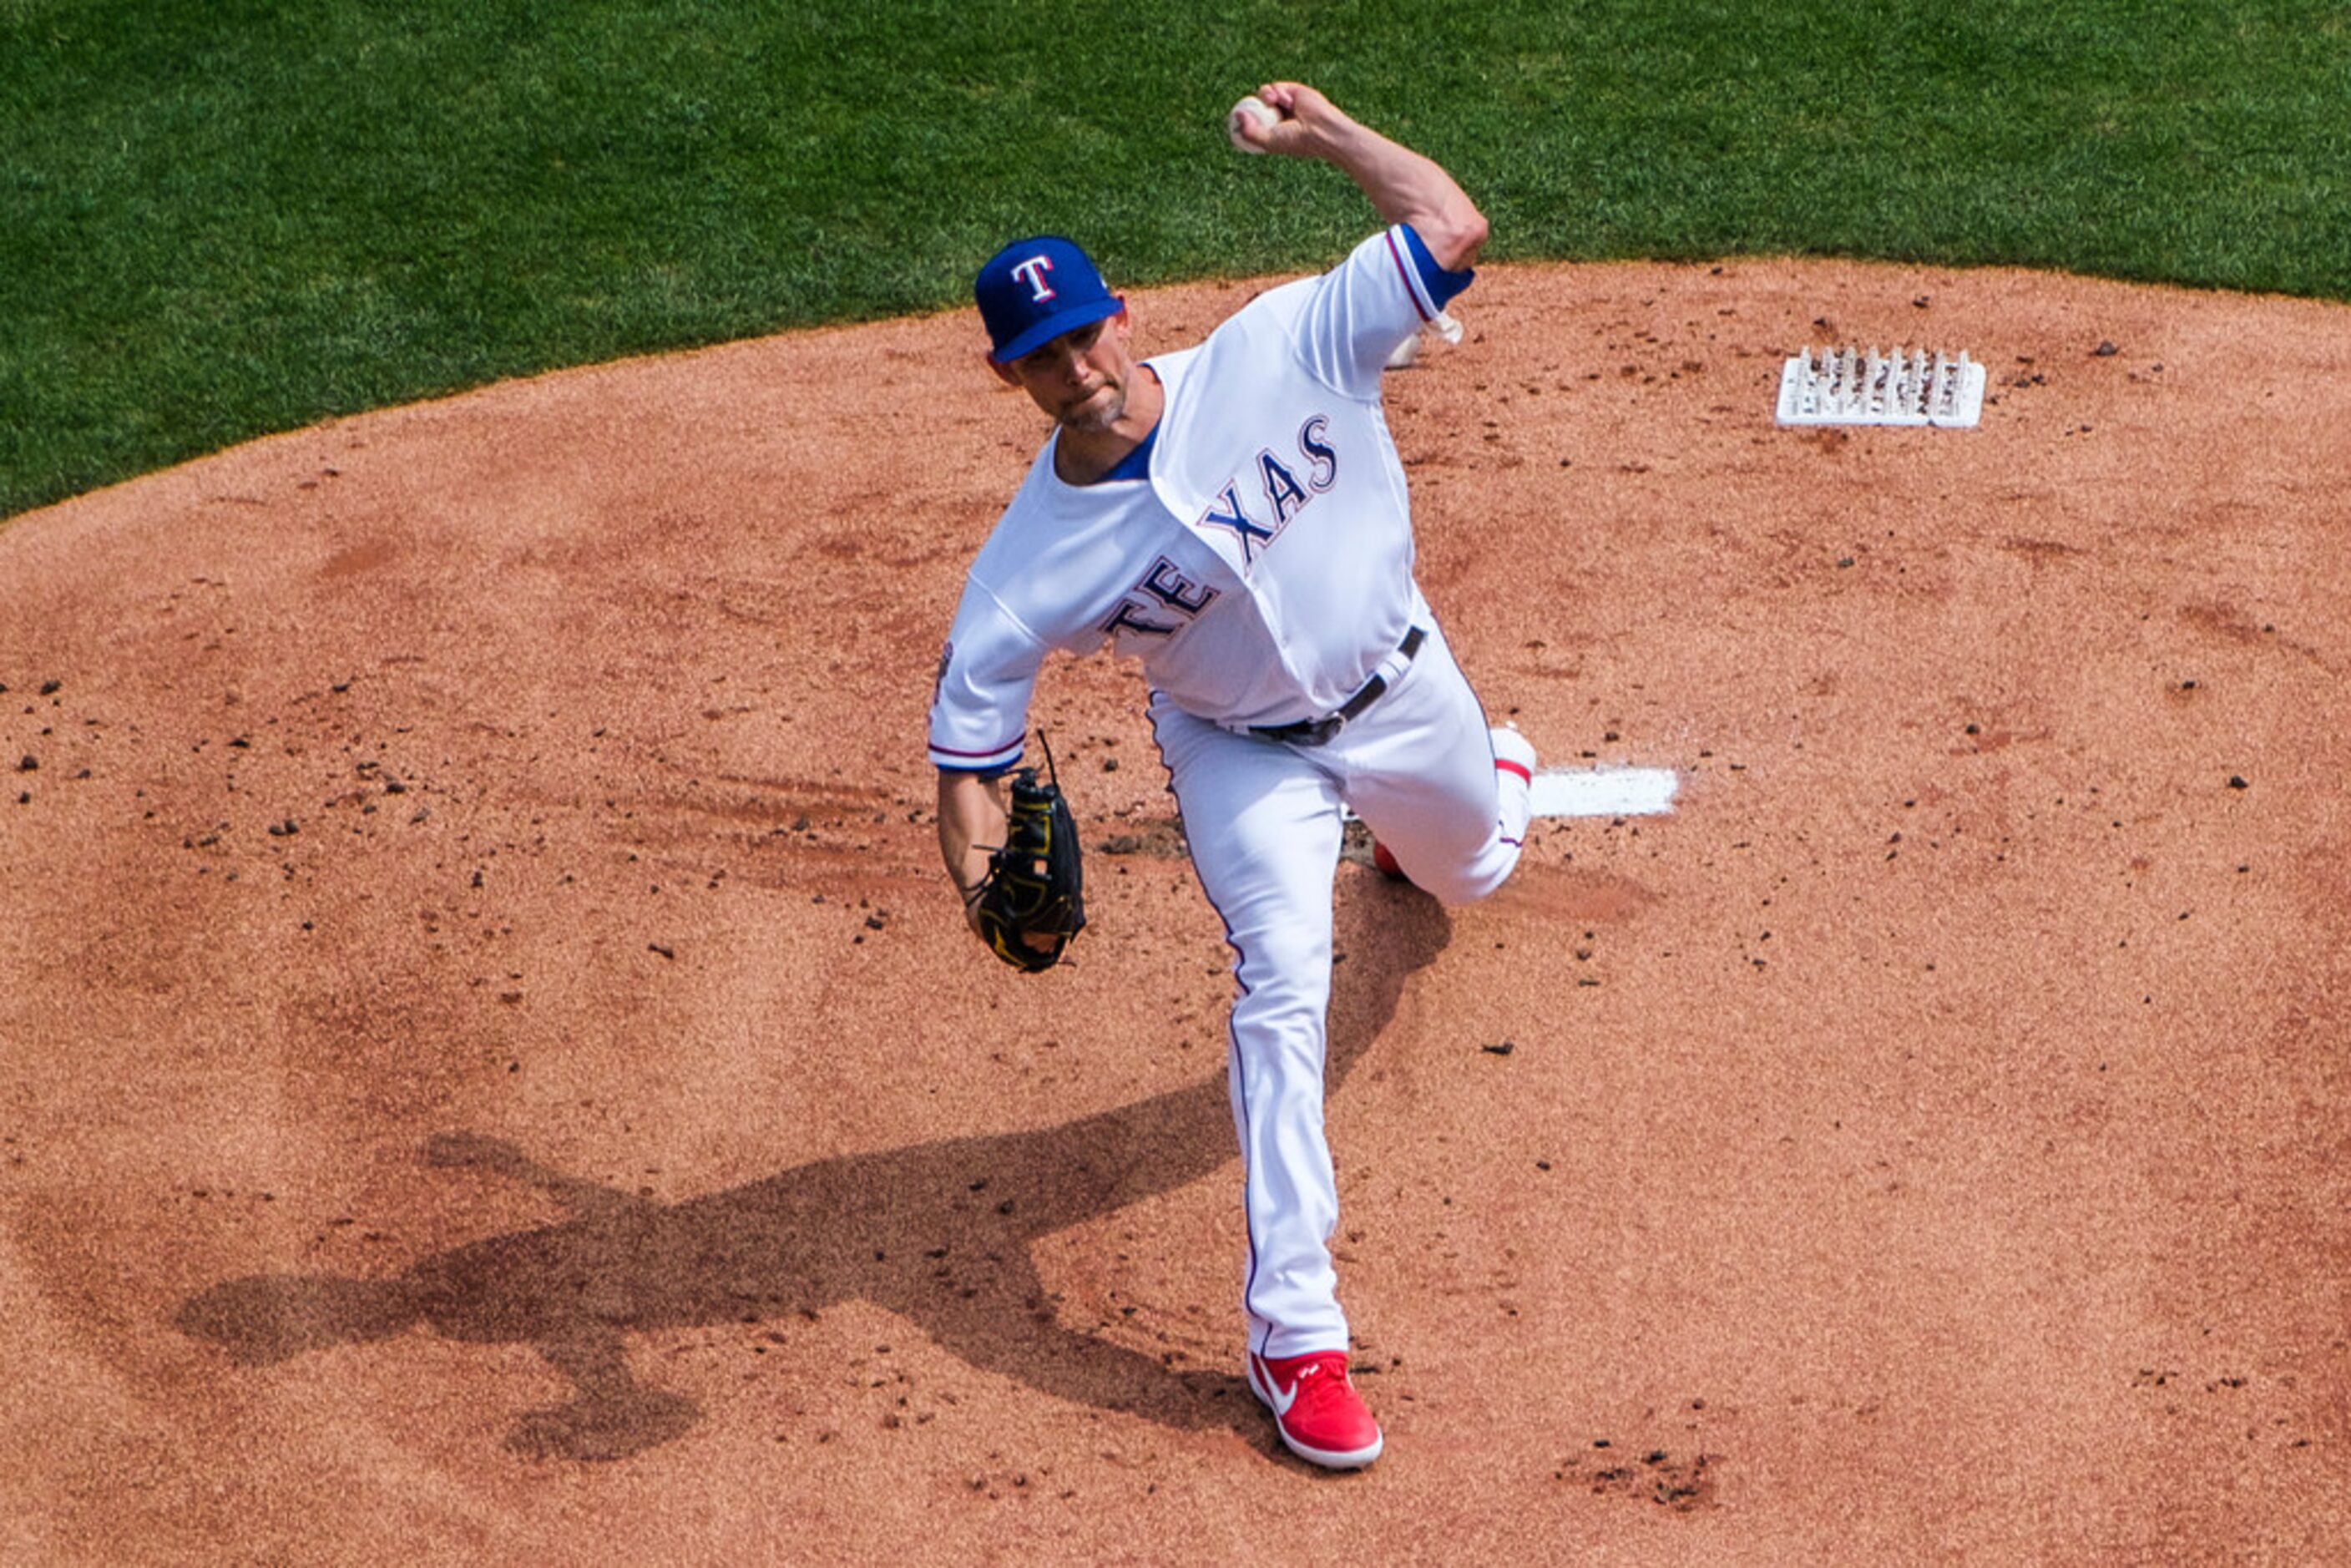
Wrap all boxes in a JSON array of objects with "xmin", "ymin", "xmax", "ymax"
[{"xmin": 931, "ymin": 223, "xmax": 1464, "ymax": 771}]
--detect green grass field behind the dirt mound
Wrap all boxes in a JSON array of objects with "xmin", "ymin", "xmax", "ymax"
[{"xmin": 0, "ymin": 0, "xmax": 2351, "ymax": 517}]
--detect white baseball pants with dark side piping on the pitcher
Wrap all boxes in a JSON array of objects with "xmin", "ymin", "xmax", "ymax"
[{"xmin": 1152, "ymin": 632, "xmax": 1528, "ymax": 1357}]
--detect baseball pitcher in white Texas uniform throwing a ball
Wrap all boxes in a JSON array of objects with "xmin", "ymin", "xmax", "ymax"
[{"xmin": 928, "ymin": 83, "xmax": 1535, "ymax": 1469}]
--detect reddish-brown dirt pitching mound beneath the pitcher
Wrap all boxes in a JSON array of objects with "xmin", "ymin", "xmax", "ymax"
[{"xmin": 0, "ymin": 263, "xmax": 2351, "ymax": 1563}]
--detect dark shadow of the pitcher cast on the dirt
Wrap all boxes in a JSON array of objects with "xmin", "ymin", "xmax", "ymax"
[{"xmin": 174, "ymin": 879, "xmax": 1450, "ymax": 1459}]
